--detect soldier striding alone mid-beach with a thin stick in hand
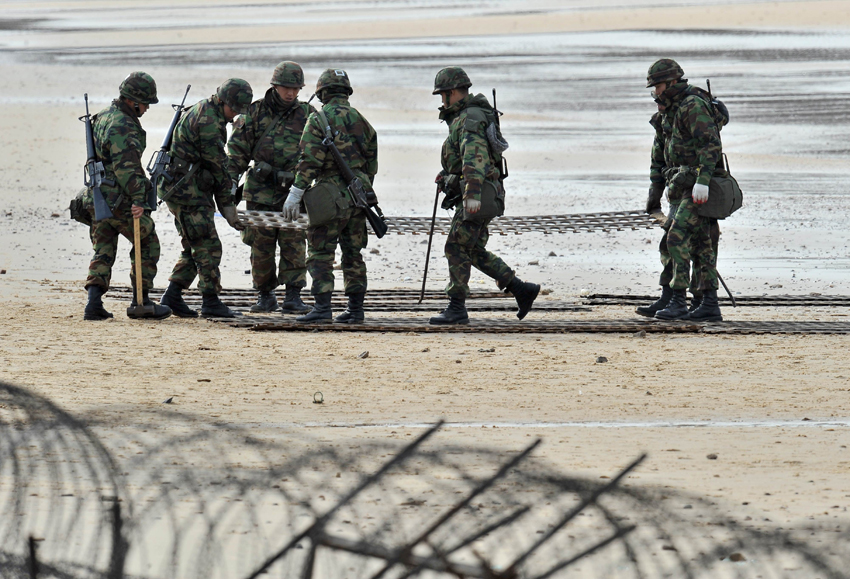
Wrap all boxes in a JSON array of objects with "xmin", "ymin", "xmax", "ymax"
[{"xmin": 430, "ymin": 66, "xmax": 540, "ymax": 324}]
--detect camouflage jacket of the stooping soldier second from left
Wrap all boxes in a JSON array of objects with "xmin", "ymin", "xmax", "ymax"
[{"xmin": 157, "ymin": 95, "xmax": 233, "ymax": 209}]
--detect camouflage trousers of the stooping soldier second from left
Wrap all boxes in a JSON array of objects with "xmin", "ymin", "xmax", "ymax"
[{"xmin": 167, "ymin": 201, "xmax": 221, "ymax": 294}]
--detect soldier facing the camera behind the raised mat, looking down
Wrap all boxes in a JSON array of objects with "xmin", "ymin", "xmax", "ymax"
[{"xmin": 227, "ymin": 62, "xmax": 314, "ymax": 313}]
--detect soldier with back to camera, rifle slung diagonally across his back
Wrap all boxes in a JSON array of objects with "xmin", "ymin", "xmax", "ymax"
[{"xmin": 283, "ymin": 68, "xmax": 378, "ymax": 323}]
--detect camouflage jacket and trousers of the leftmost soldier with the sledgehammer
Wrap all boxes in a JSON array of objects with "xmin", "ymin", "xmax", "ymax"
[{"xmin": 86, "ymin": 98, "xmax": 160, "ymax": 292}]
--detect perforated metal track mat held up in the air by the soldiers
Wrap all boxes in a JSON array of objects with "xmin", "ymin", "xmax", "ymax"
[{"xmin": 238, "ymin": 209, "xmax": 658, "ymax": 235}]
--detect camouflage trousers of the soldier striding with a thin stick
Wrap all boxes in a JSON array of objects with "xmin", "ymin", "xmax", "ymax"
[{"xmin": 445, "ymin": 204, "xmax": 516, "ymax": 298}]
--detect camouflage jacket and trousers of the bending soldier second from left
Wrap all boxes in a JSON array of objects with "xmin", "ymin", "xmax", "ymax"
[{"xmin": 158, "ymin": 95, "xmax": 233, "ymax": 294}]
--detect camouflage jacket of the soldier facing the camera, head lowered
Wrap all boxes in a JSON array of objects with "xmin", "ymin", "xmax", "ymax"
[{"xmin": 227, "ymin": 87, "xmax": 315, "ymax": 205}]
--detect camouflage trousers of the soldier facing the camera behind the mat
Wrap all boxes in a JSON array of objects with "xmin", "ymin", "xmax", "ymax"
[{"xmin": 242, "ymin": 201, "xmax": 307, "ymax": 292}]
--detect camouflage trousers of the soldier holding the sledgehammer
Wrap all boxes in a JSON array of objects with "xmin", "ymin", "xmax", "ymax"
[{"xmin": 86, "ymin": 208, "xmax": 159, "ymax": 291}]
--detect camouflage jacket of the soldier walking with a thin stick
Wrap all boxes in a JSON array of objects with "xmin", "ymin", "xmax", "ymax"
[{"xmin": 440, "ymin": 94, "xmax": 501, "ymax": 200}]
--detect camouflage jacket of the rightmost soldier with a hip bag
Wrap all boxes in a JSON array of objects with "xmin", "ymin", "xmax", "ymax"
[{"xmin": 649, "ymin": 83, "xmax": 722, "ymax": 201}]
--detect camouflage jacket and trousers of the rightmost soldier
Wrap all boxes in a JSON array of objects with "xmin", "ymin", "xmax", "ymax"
[{"xmin": 650, "ymin": 81, "xmax": 722, "ymax": 292}]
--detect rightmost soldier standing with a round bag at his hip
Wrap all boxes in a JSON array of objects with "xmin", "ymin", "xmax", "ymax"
[{"xmin": 637, "ymin": 58, "xmax": 728, "ymax": 321}]
